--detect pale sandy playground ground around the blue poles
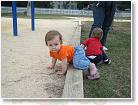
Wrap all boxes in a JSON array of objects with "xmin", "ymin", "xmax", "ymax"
[{"xmin": 1, "ymin": 18, "xmax": 78, "ymax": 98}]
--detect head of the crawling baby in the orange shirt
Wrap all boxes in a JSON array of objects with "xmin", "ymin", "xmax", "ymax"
[{"xmin": 45, "ymin": 30, "xmax": 63, "ymax": 51}]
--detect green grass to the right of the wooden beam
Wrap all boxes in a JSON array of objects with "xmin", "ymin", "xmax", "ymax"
[{"xmin": 81, "ymin": 22, "xmax": 131, "ymax": 98}]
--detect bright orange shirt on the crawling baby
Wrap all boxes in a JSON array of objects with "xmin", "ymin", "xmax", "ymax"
[{"xmin": 50, "ymin": 45, "xmax": 74, "ymax": 63}]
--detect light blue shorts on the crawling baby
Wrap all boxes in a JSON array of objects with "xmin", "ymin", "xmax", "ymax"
[{"xmin": 73, "ymin": 46, "xmax": 90, "ymax": 70}]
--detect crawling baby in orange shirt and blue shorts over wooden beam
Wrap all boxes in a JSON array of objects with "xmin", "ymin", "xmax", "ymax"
[{"xmin": 45, "ymin": 30, "xmax": 100, "ymax": 80}]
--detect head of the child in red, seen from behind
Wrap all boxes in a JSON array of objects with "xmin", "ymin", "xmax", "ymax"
[{"xmin": 91, "ymin": 27, "xmax": 103, "ymax": 39}]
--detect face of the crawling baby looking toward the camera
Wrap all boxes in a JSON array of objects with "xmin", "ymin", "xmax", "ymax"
[{"xmin": 47, "ymin": 36, "xmax": 61, "ymax": 52}]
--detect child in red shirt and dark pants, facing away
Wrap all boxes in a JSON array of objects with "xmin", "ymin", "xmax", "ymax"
[{"xmin": 81, "ymin": 27, "xmax": 111, "ymax": 64}]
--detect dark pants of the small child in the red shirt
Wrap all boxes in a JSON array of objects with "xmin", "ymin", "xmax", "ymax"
[{"xmin": 87, "ymin": 53, "xmax": 108, "ymax": 65}]
